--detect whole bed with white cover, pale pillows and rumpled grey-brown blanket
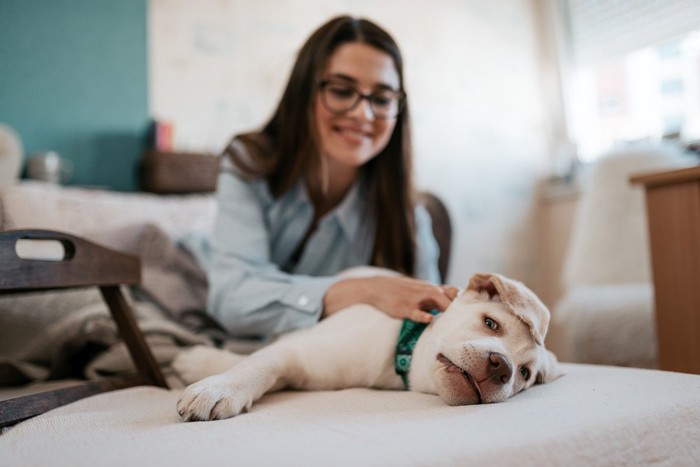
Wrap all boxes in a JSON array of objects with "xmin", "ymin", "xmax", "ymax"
[{"xmin": 0, "ymin": 182, "xmax": 700, "ymax": 466}]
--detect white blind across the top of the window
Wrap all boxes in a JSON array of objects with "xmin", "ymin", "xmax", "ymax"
[{"xmin": 559, "ymin": 0, "xmax": 700, "ymax": 67}]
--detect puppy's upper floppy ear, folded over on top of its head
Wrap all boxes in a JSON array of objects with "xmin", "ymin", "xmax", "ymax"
[{"xmin": 467, "ymin": 274, "xmax": 550, "ymax": 345}]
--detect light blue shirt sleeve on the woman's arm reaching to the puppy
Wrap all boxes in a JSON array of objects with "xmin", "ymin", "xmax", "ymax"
[{"xmin": 207, "ymin": 162, "xmax": 338, "ymax": 337}]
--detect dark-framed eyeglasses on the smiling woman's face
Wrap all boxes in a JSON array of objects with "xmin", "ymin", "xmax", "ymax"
[{"xmin": 319, "ymin": 81, "xmax": 406, "ymax": 120}]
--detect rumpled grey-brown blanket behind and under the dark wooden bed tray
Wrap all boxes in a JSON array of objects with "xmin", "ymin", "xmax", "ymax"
[{"xmin": 0, "ymin": 225, "xmax": 238, "ymax": 386}]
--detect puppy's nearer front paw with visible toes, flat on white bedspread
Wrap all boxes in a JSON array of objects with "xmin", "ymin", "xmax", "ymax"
[{"xmin": 177, "ymin": 374, "xmax": 253, "ymax": 422}]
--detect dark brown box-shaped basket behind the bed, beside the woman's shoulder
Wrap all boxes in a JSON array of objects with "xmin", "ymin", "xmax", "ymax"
[{"xmin": 139, "ymin": 150, "xmax": 219, "ymax": 194}]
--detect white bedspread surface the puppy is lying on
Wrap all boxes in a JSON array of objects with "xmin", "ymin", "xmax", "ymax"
[{"xmin": 0, "ymin": 364, "xmax": 700, "ymax": 467}]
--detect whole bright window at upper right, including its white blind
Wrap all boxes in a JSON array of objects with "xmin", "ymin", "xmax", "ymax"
[{"xmin": 561, "ymin": 0, "xmax": 700, "ymax": 162}]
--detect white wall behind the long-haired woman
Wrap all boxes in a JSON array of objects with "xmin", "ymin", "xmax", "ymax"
[{"xmin": 149, "ymin": 0, "xmax": 551, "ymax": 286}]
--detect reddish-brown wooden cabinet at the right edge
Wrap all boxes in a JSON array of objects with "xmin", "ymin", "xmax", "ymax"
[{"xmin": 631, "ymin": 166, "xmax": 700, "ymax": 374}]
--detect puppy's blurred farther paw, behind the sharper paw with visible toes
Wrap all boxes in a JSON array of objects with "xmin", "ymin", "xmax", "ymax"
[{"xmin": 171, "ymin": 345, "xmax": 244, "ymax": 384}]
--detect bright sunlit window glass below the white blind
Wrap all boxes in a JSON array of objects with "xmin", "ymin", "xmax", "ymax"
[{"xmin": 571, "ymin": 32, "xmax": 700, "ymax": 161}]
